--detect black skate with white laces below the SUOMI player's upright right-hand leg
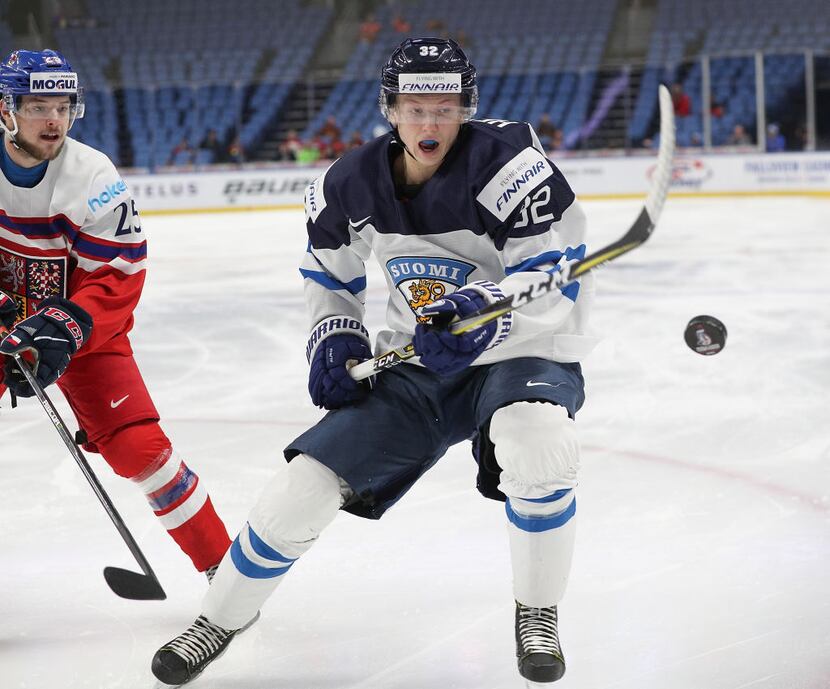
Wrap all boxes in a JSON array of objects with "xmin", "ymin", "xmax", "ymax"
[{"xmin": 516, "ymin": 602, "xmax": 565, "ymax": 683}]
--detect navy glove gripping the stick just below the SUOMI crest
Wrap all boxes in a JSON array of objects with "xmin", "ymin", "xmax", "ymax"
[{"xmin": 412, "ymin": 283, "xmax": 499, "ymax": 376}]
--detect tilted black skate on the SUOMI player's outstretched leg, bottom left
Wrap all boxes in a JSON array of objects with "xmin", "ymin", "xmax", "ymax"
[{"xmin": 153, "ymin": 615, "xmax": 238, "ymax": 686}]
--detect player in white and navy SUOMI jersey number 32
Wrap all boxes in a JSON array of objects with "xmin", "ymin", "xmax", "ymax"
[{"xmin": 152, "ymin": 38, "xmax": 595, "ymax": 684}]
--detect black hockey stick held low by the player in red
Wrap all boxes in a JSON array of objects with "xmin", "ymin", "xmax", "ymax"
[{"xmin": 0, "ymin": 342, "xmax": 167, "ymax": 600}]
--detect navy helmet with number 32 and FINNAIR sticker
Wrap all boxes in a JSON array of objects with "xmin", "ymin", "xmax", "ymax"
[{"xmin": 378, "ymin": 38, "xmax": 478, "ymax": 120}]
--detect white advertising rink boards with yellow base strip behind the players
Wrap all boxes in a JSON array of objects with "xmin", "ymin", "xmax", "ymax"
[{"xmin": 124, "ymin": 152, "xmax": 830, "ymax": 213}]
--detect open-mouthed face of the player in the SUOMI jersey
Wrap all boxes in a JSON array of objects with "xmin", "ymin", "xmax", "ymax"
[{"xmin": 390, "ymin": 94, "xmax": 465, "ymax": 177}]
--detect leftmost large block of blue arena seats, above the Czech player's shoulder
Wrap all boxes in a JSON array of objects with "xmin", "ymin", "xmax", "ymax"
[{"xmin": 55, "ymin": 0, "xmax": 331, "ymax": 167}]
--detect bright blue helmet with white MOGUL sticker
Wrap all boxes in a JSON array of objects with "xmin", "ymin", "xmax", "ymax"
[{"xmin": 0, "ymin": 50, "xmax": 84, "ymax": 131}]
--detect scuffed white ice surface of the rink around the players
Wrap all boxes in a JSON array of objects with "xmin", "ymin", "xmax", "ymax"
[{"xmin": 0, "ymin": 198, "xmax": 830, "ymax": 689}]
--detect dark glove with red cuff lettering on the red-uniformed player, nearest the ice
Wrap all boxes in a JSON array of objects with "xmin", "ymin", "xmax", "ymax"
[{"xmin": 0, "ymin": 297, "xmax": 92, "ymax": 397}]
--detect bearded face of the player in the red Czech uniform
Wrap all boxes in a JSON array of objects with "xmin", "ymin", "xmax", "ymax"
[{"xmin": 6, "ymin": 96, "xmax": 72, "ymax": 164}]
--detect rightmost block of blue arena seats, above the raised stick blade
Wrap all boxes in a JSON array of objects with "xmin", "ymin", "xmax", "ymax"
[{"xmin": 629, "ymin": 0, "xmax": 830, "ymax": 146}]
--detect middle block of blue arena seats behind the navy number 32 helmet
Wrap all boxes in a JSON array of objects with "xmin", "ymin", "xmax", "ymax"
[{"xmin": 301, "ymin": 0, "xmax": 616, "ymax": 145}]
